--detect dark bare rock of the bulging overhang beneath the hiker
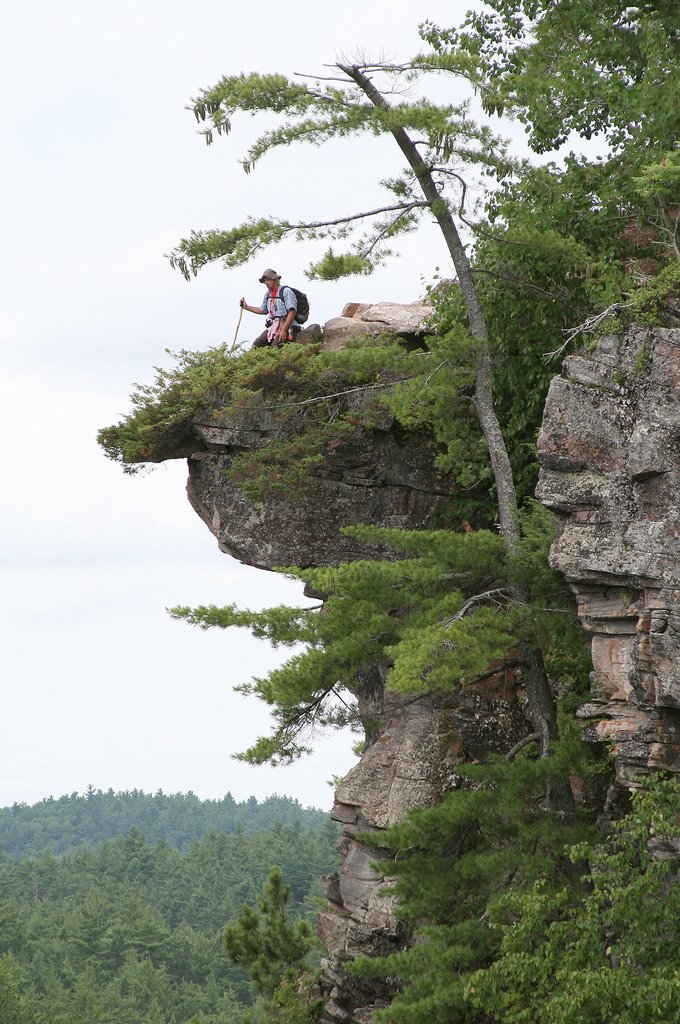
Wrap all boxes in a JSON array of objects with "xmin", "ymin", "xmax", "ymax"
[{"xmin": 187, "ymin": 416, "xmax": 454, "ymax": 568}]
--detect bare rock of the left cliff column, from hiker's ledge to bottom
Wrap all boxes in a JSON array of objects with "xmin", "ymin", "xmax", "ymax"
[{"xmin": 169, "ymin": 303, "xmax": 532, "ymax": 1024}]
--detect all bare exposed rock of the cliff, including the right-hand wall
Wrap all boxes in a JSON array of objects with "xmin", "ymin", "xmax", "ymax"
[{"xmin": 151, "ymin": 294, "xmax": 680, "ymax": 1024}]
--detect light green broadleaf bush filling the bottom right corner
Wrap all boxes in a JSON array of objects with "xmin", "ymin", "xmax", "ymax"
[{"xmin": 468, "ymin": 778, "xmax": 680, "ymax": 1024}]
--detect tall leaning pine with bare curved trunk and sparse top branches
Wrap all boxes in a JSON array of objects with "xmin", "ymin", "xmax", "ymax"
[{"xmin": 170, "ymin": 57, "xmax": 571, "ymax": 790}]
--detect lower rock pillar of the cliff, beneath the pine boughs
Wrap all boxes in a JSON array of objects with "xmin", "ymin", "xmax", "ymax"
[{"xmin": 318, "ymin": 670, "xmax": 532, "ymax": 1024}]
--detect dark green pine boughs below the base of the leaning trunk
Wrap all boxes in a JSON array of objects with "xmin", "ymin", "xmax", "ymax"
[{"xmin": 352, "ymin": 720, "xmax": 600, "ymax": 1024}]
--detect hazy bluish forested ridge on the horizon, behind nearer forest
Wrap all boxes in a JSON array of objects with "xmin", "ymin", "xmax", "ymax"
[{"xmin": 0, "ymin": 786, "xmax": 328, "ymax": 860}]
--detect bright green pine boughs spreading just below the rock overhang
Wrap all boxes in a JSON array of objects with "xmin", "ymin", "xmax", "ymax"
[{"xmin": 172, "ymin": 503, "xmax": 588, "ymax": 764}]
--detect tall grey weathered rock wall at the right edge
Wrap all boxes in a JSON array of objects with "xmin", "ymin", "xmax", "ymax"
[{"xmin": 538, "ymin": 328, "xmax": 680, "ymax": 798}]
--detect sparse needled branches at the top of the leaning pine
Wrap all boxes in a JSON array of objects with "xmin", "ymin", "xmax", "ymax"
[{"xmin": 165, "ymin": 66, "xmax": 510, "ymax": 280}]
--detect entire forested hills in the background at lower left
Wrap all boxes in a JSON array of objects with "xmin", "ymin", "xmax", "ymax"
[{"xmin": 0, "ymin": 787, "xmax": 337, "ymax": 1024}]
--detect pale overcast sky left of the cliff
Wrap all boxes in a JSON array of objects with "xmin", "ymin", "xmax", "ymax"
[{"xmin": 0, "ymin": 0, "xmax": 499, "ymax": 807}]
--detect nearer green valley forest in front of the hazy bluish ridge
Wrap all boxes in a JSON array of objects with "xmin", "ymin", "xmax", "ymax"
[{"xmin": 0, "ymin": 823, "xmax": 338, "ymax": 1024}]
